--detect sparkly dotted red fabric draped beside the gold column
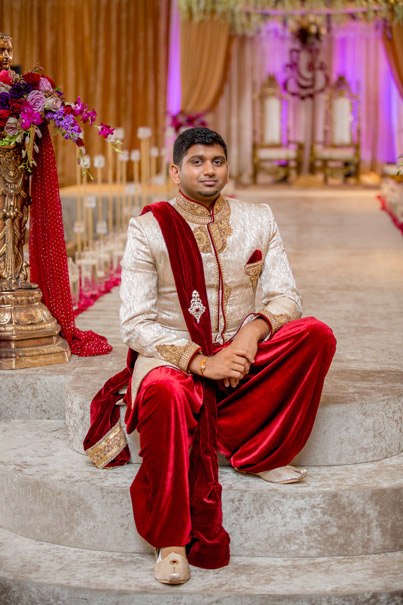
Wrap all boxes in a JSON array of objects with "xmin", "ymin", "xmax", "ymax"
[{"xmin": 29, "ymin": 124, "xmax": 112, "ymax": 357}]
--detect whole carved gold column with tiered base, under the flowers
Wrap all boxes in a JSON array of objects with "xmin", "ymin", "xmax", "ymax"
[{"xmin": 0, "ymin": 146, "xmax": 70, "ymax": 370}]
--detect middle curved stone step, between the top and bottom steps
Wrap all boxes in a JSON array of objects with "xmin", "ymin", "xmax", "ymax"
[{"xmin": 0, "ymin": 421, "xmax": 403, "ymax": 558}]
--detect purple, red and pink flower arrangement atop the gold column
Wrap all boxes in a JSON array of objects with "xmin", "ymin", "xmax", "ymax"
[{"xmin": 0, "ymin": 65, "xmax": 120, "ymax": 176}]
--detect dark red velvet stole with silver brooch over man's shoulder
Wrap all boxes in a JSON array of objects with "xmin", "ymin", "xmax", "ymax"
[{"xmin": 84, "ymin": 202, "xmax": 230, "ymax": 569}]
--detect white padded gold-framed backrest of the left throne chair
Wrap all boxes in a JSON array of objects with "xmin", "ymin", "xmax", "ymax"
[{"xmin": 259, "ymin": 74, "xmax": 285, "ymax": 146}]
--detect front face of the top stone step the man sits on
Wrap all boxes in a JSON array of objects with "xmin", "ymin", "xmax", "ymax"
[{"xmin": 66, "ymin": 365, "xmax": 403, "ymax": 466}]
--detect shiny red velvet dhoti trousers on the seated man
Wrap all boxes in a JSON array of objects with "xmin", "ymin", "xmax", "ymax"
[{"xmin": 130, "ymin": 317, "xmax": 336, "ymax": 547}]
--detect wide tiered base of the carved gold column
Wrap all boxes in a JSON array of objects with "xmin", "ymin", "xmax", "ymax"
[{"xmin": 0, "ymin": 282, "xmax": 71, "ymax": 370}]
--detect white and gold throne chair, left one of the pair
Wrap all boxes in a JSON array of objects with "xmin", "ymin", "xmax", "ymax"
[{"xmin": 253, "ymin": 74, "xmax": 302, "ymax": 183}]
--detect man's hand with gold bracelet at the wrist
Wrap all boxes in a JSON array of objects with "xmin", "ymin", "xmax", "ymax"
[{"xmin": 189, "ymin": 347, "xmax": 250, "ymax": 388}]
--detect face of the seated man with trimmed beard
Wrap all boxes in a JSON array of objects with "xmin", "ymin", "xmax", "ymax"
[{"xmin": 170, "ymin": 145, "xmax": 229, "ymax": 204}]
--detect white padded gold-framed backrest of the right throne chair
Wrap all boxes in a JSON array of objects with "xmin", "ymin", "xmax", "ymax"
[{"xmin": 329, "ymin": 76, "xmax": 359, "ymax": 146}]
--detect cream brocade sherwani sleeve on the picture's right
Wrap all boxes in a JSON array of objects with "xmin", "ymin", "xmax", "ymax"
[{"xmin": 258, "ymin": 207, "xmax": 302, "ymax": 335}]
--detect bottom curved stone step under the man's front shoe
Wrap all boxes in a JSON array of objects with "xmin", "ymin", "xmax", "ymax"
[{"xmin": 0, "ymin": 529, "xmax": 403, "ymax": 605}]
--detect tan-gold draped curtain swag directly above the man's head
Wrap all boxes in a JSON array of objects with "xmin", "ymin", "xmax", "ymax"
[{"xmin": 180, "ymin": 19, "xmax": 234, "ymax": 113}]
